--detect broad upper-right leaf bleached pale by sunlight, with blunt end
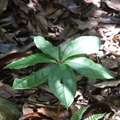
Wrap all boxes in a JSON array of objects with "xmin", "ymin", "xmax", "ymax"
[{"xmin": 61, "ymin": 36, "xmax": 101, "ymax": 61}]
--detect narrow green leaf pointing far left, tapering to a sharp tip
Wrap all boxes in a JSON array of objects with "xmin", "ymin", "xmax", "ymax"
[{"xmin": 4, "ymin": 53, "xmax": 56, "ymax": 69}]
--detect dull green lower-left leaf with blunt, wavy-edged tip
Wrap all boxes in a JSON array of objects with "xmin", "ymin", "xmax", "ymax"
[{"xmin": 12, "ymin": 67, "xmax": 51, "ymax": 89}]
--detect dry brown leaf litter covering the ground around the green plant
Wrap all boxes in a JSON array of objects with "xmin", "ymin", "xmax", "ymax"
[{"xmin": 0, "ymin": 0, "xmax": 120, "ymax": 120}]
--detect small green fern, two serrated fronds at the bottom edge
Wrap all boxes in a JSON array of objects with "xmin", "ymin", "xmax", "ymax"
[{"xmin": 70, "ymin": 106, "xmax": 105, "ymax": 120}]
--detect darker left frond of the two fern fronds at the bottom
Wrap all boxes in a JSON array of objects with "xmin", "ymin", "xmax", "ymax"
[{"xmin": 70, "ymin": 106, "xmax": 89, "ymax": 120}]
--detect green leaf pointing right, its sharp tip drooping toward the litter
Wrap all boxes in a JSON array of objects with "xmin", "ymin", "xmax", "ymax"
[{"xmin": 64, "ymin": 57, "xmax": 114, "ymax": 79}]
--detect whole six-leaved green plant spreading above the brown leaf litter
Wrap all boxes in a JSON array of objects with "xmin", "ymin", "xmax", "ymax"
[{"xmin": 5, "ymin": 36, "xmax": 114, "ymax": 108}]
